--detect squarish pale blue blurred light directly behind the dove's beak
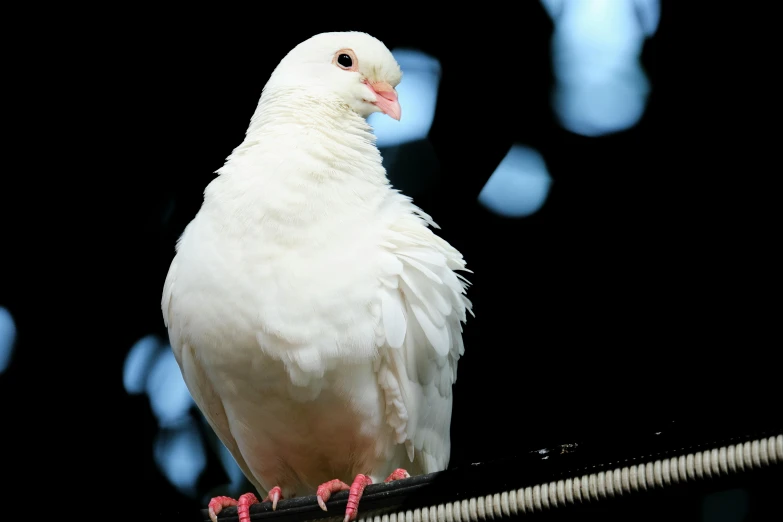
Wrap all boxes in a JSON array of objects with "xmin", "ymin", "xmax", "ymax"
[{"xmin": 367, "ymin": 49, "xmax": 441, "ymax": 147}]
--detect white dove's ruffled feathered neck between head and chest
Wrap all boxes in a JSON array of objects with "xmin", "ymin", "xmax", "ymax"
[{"xmin": 208, "ymin": 88, "xmax": 389, "ymax": 231}]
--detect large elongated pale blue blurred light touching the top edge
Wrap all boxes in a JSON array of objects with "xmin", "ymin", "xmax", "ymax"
[{"xmin": 541, "ymin": 0, "xmax": 660, "ymax": 136}]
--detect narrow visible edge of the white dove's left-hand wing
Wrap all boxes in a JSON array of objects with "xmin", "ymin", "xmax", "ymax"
[{"xmin": 161, "ymin": 259, "xmax": 267, "ymax": 495}]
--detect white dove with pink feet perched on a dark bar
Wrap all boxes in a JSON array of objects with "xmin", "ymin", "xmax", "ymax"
[{"xmin": 162, "ymin": 32, "xmax": 472, "ymax": 522}]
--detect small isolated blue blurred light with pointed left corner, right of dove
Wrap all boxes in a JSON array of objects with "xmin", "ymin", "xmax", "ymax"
[{"xmin": 478, "ymin": 145, "xmax": 552, "ymax": 218}]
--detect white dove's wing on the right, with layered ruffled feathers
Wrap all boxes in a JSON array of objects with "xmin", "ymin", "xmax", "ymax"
[{"xmin": 376, "ymin": 205, "xmax": 472, "ymax": 473}]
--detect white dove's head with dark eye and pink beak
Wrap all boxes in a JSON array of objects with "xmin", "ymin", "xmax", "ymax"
[{"xmin": 266, "ymin": 32, "xmax": 402, "ymax": 120}]
